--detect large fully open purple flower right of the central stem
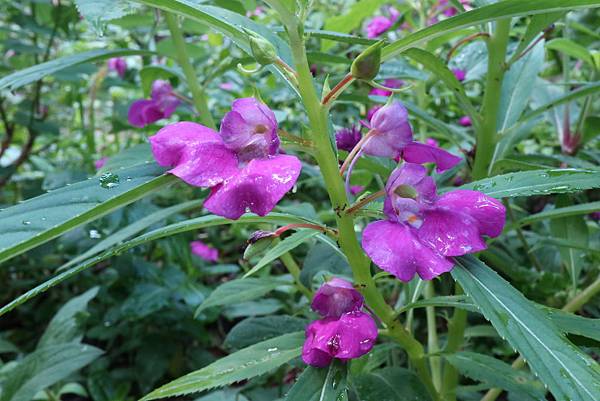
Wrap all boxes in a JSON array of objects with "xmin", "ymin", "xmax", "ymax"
[{"xmin": 362, "ymin": 163, "xmax": 505, "ymax": 282}]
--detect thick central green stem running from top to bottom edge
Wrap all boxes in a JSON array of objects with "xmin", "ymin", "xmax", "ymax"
[{"xmin": 284, "ymin": 14, "xmax": 439, "ymax": 401}]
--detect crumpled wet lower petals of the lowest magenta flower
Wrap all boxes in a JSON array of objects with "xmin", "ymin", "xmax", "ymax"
[{"xmin": 302, "ymin": 311, "xmax": 377, "ymax": 367}]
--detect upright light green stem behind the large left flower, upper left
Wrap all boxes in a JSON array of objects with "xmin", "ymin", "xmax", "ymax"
[{"xmin": 165, "ymin": 12, "xmax": 217, "ymax": 129}]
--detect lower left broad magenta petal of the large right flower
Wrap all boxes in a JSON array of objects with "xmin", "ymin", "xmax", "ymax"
[{"xmin": 362, "ymin": 221, "xmax": 453, "ymax": 282}]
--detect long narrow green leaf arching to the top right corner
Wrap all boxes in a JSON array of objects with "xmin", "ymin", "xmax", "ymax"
[{"xmin": 382, "ymin": 0, "xmax": 600, "ymax": 61}]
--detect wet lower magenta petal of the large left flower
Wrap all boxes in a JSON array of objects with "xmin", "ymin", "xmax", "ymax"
[{"xmin": 204, "ymin": 155, "xmax": 302, "ymax": 219}]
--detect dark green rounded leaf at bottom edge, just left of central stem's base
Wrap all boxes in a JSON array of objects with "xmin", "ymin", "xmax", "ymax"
[{"xmin": 352, "ymin": 367, "xmax": 431, "ymax": 401}]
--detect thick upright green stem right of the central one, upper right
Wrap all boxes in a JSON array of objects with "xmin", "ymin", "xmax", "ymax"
[{"xmin": 473, "ymin": 19, "xmax": 510, "ymax": 180}]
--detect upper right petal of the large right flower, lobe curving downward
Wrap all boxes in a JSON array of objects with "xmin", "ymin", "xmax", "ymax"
[{"xmin": 436, "ymin": 189, "xmax": 506, "ymax": 237}]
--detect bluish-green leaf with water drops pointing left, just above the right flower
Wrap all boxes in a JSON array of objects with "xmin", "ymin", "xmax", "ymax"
[{"xmin": 460, "ymin": 168, "xmax": 600, "ymax": 198}]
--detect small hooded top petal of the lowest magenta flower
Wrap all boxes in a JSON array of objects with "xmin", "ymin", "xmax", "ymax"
[{"xmin": 311, "ymin": 278, "xmax": 364, "ymax": 318}]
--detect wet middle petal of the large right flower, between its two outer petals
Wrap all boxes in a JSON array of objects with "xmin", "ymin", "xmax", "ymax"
[{"xmin": 417, "ymin": 208, "xmax": 487, "ymax": 256}]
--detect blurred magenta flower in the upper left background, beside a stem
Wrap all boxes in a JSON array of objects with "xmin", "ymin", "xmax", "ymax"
[{"xmin": 127, "ymin": 80, "xmax": 181, "ymax": 128}]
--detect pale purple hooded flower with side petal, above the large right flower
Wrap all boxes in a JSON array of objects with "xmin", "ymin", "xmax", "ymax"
[{"xmin": 363, "ymin": 101, "xmax": 461, "ymax": 172}]
